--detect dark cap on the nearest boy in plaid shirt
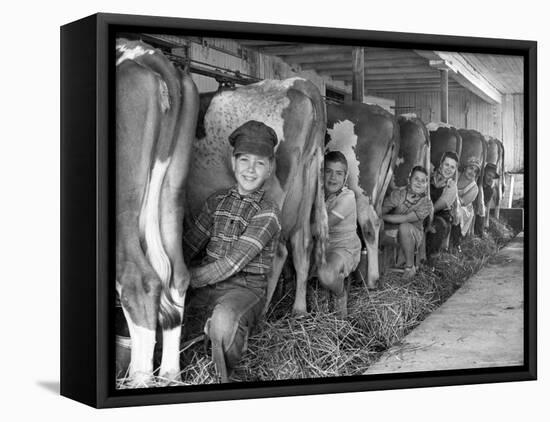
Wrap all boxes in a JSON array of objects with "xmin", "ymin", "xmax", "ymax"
[{"xmin": 229, "ymin": 120, "xmax": 278, "ymax": 158}]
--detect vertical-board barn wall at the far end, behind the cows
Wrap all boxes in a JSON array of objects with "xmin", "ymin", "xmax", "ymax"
[{"xmin": 376, "ymin": 88, "xmax": 524, "ymax": 172}]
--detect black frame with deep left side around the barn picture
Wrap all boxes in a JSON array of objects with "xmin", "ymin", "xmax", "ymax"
[{"xmin": 61, "ymin": 14, "xmax": 537, "ymax": 408}]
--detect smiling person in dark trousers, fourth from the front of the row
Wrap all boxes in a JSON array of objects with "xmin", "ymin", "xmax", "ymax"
[{"xmin": 426, "ymin": 151, "xmax": 458, "ymax": 256}]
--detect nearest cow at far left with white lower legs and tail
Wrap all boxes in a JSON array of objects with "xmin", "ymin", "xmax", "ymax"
[{"xmin": 116, "ymin": 39, "xmax": 198, "ymax": 387}]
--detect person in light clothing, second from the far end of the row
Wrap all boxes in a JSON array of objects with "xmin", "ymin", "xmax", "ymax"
[{"xmin": 452, "ymin": 157, "xmax": 481, "ymax": 246}]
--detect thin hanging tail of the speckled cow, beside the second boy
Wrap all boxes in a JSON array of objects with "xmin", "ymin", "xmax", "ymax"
[{"xmin": 313, "ymin": 146, "xmax": 328, "ymax": 265}]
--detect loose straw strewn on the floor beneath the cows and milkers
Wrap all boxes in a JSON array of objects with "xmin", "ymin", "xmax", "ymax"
[{"xmin": 116, "ymin": 219, "xmax": 514, "ymax": 387}]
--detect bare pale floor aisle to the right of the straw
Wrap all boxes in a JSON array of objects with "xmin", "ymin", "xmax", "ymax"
[{"xmin": 365, "ymin": 234, "xmax": 523, "ymax": 374}]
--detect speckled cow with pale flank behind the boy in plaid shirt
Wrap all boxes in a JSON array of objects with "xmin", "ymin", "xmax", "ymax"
[{"xmin": 187, "ymin": 78, "xmax": 328, "ymax": 315}]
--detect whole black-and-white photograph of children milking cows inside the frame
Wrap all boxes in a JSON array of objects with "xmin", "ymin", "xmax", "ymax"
[{"xmin": 114, "ymin": 31, "xmax": 528, "ymax": 390}]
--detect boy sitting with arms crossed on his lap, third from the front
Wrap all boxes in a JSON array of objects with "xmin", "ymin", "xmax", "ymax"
[{"xmin": 382, "ymin": 166, "xmax": 433, "ymax": 278}]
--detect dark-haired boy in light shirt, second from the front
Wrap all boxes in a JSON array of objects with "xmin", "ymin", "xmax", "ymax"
[{"xmin": 317, "ymin": 151, "xmax": 361, "ymax": 317}]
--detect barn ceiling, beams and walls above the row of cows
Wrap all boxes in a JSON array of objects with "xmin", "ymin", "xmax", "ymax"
[{"xmin": 126, "ymin": 34, "xmax": 524, "ymax": 208}]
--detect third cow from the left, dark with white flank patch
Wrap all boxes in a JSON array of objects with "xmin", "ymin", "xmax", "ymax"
[{"xmin": 326, "ymin": 103, "xmax": 399, "ymax": 289}]
